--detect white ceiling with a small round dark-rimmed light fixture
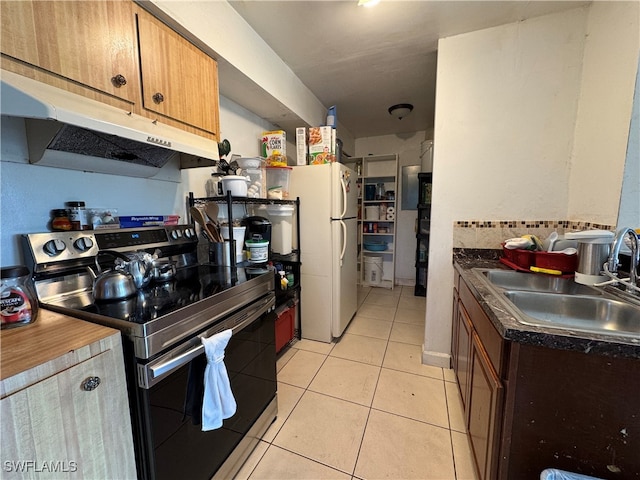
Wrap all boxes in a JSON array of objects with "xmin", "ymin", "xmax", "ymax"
[{"xmin": 229, "ymin": 0, "xmax": 591, "ymax": 138}]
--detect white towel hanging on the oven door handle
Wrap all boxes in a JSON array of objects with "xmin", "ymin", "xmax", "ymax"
[{"xmin": 200, "ymin": 330, "xmax": 236, "ymax": 432}]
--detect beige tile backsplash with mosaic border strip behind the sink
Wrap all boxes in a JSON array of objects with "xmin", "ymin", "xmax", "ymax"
[{"xmin": 453, "ymin": 220, "xmax": 615, "ymax": 249}]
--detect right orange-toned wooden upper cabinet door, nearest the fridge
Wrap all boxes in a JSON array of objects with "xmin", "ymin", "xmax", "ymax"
[{"xmin": 137, "ymin": 10, "xmax": 218, "ymax": 135}]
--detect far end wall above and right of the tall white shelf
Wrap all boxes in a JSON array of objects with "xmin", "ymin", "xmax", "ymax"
[{"xmin": 355, "ymin": 131, "xmax": 426, "ymax": 285}]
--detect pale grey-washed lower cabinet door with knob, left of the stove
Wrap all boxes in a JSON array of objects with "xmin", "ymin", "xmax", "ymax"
[{"xmin": 0, "ymin": 350, "xmax": 136, "ymax": 479}]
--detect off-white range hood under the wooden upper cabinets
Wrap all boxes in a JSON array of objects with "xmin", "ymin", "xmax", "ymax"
[{"xmin": 0, "ymin": 70, "xmax": 219, "ymax": 177}]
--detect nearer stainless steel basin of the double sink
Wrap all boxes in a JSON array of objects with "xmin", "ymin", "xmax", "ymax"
[{"xmin": 504, "ymin": 291, "xmax": 640, "ymax": 336}]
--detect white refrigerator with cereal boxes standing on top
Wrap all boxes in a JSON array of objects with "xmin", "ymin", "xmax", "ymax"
[{"xmin": 289, "ymin": 163, "xmax": 358, "ymax": 342}]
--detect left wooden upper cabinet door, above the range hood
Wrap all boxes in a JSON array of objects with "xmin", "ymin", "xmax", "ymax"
[{"xmin": 0, "ymin": 0, "xmax": 140, "ymax": 104}]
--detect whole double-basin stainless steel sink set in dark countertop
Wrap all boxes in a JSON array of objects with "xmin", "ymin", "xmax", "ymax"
[{"xmin": 475, "ymin": 269, "xmax": 640, "ymax": 338}]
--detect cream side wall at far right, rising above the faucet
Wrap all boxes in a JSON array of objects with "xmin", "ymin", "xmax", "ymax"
[{"xmin": 568, "ymin": 2, "xmax": 640, "ymax": 225}]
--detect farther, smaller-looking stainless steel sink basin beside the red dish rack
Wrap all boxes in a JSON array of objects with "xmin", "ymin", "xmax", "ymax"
[{"xmin": 483, "ymin": 270, "xmax": 602, "ymax": 295}]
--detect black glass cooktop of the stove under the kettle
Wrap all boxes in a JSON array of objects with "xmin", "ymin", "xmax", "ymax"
[{"xmin": 64, "ymin": 264, "xmax": 273, "ymax": 324}]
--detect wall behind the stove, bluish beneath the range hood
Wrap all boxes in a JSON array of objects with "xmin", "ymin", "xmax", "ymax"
[{"xmin": 0, "ymin": 97, "xmax": 274, "ymax": 265}]
